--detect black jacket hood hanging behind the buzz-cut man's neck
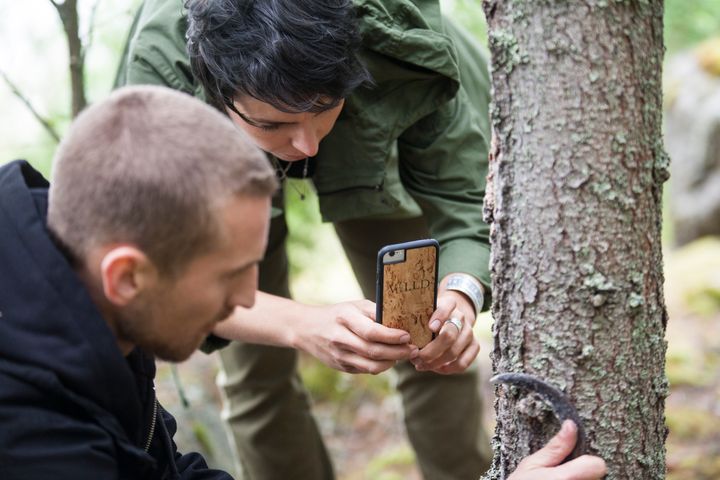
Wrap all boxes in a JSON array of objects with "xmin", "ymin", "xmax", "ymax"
[{"xmin": 0, "ymin": 161, "xmax": 141, "ymax": 443}]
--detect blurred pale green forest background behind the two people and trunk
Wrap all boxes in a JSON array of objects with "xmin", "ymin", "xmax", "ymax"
[{"xmin": 0, "ymin": 0, "xmax": 720, "ymax": 480}]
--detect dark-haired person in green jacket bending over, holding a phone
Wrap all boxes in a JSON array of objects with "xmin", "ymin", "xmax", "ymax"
[{"xmin": 117, "ymin": 0, "xmax": 608, "ymax": 480}]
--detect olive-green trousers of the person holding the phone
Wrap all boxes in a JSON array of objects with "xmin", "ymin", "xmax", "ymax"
[{"xmin": 218, "ymin": 203, "xmax": 490, "ymax": 480}]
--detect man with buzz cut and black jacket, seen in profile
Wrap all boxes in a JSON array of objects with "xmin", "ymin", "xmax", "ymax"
[{"xmin": 0, "ymin": 87, "xmax": 276, "ymax": 480}]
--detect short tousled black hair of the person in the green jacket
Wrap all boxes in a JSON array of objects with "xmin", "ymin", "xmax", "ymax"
[{"xmin": 185, "ymin": 0, "xmax": 371, "ymax": 113}]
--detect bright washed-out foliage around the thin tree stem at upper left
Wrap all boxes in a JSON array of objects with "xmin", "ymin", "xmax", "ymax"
[{"xmin": 0, "ymin": 0, "xmax": 141, "ymax": 176}]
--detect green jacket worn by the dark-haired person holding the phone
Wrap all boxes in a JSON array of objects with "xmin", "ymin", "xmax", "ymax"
[{"xmin": 116, "ymin": 0, "xmax": 490, "ymax": 286}]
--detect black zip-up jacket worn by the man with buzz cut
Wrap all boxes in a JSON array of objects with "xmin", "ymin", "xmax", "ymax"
[{"xmin": 0, "ymin": 161, "xmax": 231, "ymax": 480}]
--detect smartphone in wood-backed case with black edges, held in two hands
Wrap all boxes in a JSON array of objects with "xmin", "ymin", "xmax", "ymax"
[{"xmin": 375, "ymin": 239, "xmax": 439, "ymax": 348}]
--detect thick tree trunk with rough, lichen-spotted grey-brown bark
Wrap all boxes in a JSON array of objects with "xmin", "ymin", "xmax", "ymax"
[{"xmin": 484, "ymin": 0, "xmax": 669, "ymax": 480}]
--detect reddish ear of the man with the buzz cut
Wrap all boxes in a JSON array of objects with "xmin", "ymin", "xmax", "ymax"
[{"xmin": 100, "ymin": 245, "xmax": 158, "ymax": 306}]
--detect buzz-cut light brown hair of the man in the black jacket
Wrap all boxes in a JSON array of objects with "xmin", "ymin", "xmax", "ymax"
[{"xmin": 48, "ymin": 86, "xmax": 277, "ymax": 276}]
